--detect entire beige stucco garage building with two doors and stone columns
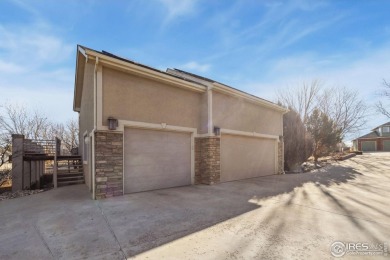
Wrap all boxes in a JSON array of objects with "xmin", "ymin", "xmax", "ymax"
[{"xmin": 73, "ymin": 46, "xmax": 288, "ymax": 198}]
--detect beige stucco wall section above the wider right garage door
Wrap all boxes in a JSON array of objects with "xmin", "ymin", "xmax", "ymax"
[{"xmin": 213, "ymin": 91, "xmax": 283, "ymax": 135}]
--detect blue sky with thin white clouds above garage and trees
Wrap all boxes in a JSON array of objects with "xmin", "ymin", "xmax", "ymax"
[{"xmin": 0, "ymin": 0, "xmax": 390, "ymax": 141}]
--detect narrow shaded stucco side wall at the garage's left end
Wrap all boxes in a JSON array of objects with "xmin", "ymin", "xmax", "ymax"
[{"xmin": 79, "ymin": 62, "xmax": 95, "ymax": 188}]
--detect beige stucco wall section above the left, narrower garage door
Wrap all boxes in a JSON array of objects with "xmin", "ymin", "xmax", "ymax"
[{"xmin": 102, "ymin": 67, "xmax": 202, "ymax": 128}]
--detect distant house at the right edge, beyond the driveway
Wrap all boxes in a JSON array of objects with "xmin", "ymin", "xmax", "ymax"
[{"xmin": 353, "ymin": 122, "xmax": 390, "ymax": 152}]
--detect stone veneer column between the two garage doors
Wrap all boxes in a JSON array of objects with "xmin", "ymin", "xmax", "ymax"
[{"xmin": 195, "ymin": 136, "xmax": 221, "ymax": 185}]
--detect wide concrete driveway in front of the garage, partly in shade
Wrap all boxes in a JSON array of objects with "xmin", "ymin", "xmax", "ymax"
[{"xmin": 0, "ymin": 153, "xmax": 390, "ymax": 259}]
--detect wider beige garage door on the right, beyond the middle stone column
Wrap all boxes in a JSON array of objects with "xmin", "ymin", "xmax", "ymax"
[{"xmin": 221, "ymin": 135, "xmax": 276, "ymax": 182}]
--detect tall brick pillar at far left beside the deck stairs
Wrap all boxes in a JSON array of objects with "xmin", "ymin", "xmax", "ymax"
[{"xmin": 12, "ymin": 134, "xmax": 24, "ymax": 191}]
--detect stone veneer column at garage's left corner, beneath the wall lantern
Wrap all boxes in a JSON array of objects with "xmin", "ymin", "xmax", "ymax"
[{"xmin": 95, "ymin": 131, "xmax": 123, "ymax": 199}]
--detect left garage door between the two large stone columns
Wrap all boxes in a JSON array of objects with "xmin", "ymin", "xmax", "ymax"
[{"xmin": 124, "ymin": 128, "xmax": 191, "ymax": 193}]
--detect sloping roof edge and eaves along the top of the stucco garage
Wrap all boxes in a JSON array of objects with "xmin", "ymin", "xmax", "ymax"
[{"xmin": 73, "ymin": 45, "xmax": 288, "ymax": 113}]
